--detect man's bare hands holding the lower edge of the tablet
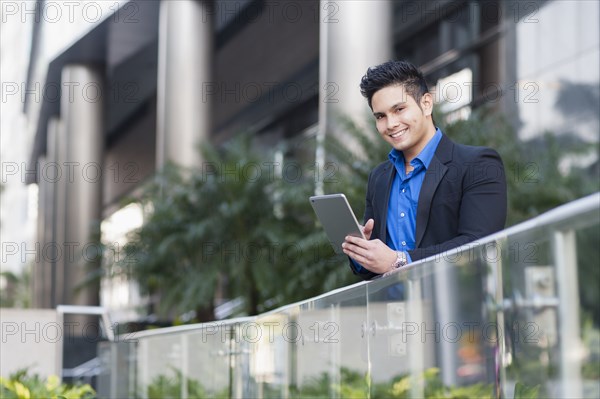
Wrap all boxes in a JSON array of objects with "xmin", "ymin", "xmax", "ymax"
[{"xmin": 342, "ymin": 227, "xmax": 397, "ymax": 274}]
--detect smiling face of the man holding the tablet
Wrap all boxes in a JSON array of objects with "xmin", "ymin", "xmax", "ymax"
[{"xmin": 371, "ymin": 85, "xmax": 435, "ymax": 162}]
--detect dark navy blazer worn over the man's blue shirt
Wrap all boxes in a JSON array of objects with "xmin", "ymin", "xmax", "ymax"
[{"xmin": 351, "ymin": 135, "xmax": 507, "ymax": 279}]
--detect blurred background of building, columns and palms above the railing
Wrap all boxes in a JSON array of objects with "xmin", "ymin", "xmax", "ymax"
[{"xmin": 0, "ymin": 0, "xmax": 600, "ymax": 396}]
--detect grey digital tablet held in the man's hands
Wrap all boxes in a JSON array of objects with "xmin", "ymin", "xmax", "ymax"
[{"xmin": 310, "ymin": 194, "xmax": 365, "ymax": 254}]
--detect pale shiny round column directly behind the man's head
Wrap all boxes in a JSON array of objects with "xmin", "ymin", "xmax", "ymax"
[{"xmin": 319, "ymin": 0, "xmax": 393, "ymax": 138}]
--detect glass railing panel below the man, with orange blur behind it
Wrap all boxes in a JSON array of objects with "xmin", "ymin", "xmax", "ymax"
[{"xmin": 368, "ymin": 250, "xmax": 498, "ymax": 397}]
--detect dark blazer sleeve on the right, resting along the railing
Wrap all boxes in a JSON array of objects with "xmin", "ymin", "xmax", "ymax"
[{"xmin": 409, "ymin": 147, "xmax": 507, "ymax": 261}]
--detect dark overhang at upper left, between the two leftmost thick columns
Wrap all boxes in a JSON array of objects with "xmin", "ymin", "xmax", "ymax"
[{"xmin": 25, "ymin": 0, "xmax": 160, "ymax": 184}]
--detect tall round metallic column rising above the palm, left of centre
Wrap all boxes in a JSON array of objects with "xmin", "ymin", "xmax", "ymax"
[{"xmin": 156, "ymin": 0, "xmax": 214, "ymax": 168}]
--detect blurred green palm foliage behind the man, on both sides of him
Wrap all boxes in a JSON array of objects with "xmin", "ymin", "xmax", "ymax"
[{"xmin": 112, "ymin": 110, "xmax": 594, "ymax": 320}]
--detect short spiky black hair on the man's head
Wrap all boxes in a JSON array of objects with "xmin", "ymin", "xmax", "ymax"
[{"xmin": 360, "ymin": 61, "xmax": 429, "ymax": 109}]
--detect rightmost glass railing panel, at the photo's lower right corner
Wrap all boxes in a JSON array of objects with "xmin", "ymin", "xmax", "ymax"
[{"xmin": 499, "ymin": 205, "xmax": 600, "ymax": 398}]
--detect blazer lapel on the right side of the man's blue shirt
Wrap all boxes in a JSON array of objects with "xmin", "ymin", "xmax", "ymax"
[{"xmin": 415, "ymin": 135, "xmax": 454, "ymax": 248}]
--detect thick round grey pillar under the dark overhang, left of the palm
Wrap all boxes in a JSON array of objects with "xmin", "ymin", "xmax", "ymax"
[{"xmin": 57, "ymin": 65, "xmax": 104, "ymax": 305}]
